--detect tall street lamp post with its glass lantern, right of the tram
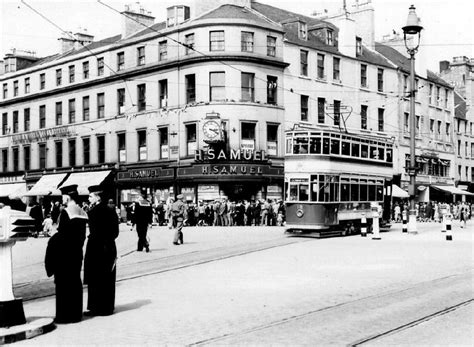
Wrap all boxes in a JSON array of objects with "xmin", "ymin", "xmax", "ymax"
[{"xmin": 402, "ymin": 5, "xmax": 423, "ymax": 234}]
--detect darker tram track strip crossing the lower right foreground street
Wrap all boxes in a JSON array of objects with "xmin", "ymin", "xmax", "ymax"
[{"xmin": 188, "ymin": 270, "xmax": 474, "ymax": 346}]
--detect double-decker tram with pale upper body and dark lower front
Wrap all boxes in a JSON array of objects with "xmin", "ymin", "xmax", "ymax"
[{"xmin": 285, "ymin": 125, "xmax": 393, "ymax": 236}]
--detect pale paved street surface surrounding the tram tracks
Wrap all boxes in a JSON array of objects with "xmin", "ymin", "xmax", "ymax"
[{"xmin": 4, "ymin": 221, "xmax": 474, "ymax": 346}]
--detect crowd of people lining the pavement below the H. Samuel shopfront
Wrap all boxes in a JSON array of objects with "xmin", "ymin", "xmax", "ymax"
[{"xmin": 127, "ymin": 198, "xmax": 286, "ymax": 228}]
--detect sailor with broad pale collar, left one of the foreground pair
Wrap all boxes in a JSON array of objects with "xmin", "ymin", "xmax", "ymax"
[{"xmin": 45, "ymin": 184, "xmax": 87, "ymax": 323}]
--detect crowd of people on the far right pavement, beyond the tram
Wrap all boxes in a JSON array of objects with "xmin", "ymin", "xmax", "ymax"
[{"xmin": 392, "ymin": 201, "xmax": 472, "ymax": 224}]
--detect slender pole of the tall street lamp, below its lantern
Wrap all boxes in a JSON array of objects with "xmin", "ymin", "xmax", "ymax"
[{"xmin": 408, "ymin": 49, "xmax": 418, "ymax": 234}]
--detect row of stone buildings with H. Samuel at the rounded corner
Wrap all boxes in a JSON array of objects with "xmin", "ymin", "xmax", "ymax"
[{"xmin": 0, "ymin": 0, "xmax": 473, "ymax": 204}]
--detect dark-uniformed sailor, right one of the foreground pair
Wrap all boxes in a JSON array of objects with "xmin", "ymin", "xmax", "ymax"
[{"xmin": 84, "ymin": 186, "xmax": 119, "ymax": 316}]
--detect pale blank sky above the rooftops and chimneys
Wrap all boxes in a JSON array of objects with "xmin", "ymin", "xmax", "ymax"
[{"xmin": 0, "ymin": 0, "xmax": 474, "ymax": 72}]
